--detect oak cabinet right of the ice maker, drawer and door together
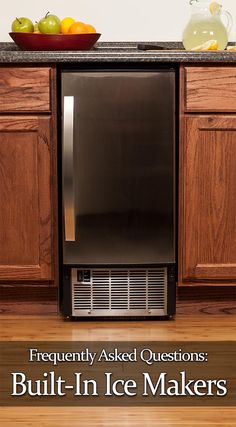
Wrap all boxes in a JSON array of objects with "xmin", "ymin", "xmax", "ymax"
[{"xmin": 178, "ymin": 64, "xmax": 236, "ymax": 286}]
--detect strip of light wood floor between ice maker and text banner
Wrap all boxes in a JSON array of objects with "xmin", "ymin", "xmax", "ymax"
[{"xmin": 0, "ymin": 314, "xmax": 236, "ymax": 341}]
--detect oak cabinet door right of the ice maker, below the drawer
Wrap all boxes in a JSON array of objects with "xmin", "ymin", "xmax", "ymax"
[{"xmin": 180, "ymin": 116, "xmax": 236, "ymax": 281}]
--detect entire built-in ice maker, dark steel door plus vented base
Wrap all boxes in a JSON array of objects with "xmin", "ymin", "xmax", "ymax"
[{"xmin": 60, "ymin": 67, "xmax": 176, "ymax": 317}]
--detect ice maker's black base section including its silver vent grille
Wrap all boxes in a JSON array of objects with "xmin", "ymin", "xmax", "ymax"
[{"xmin": 61, "ymin": 264, "xmax": 176, "ymax": 318}]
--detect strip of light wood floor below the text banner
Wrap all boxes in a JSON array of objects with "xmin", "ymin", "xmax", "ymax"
[{"xmin": 0, "ymin": 407, "xmax": 236, "ymax": 427}]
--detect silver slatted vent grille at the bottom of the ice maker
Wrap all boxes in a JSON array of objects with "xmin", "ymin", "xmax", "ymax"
[{"xmin": 71, "ymin": 268, "xmax": 167, "ymax": 316}]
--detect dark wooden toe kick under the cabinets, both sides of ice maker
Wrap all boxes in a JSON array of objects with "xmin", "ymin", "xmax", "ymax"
[{"xmin": 0, "ymin": 282, "xmax": 236, "ymax": 316}]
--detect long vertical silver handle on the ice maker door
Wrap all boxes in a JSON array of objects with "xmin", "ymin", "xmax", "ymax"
[{"xmin": 63, "ymin": 96, "xmax": 76, "ymax": 242}]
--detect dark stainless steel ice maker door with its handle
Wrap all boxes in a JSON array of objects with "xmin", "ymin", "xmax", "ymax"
[{"xmin": 62, "ymin": 70, "xmax": 175, "ymax": 265}]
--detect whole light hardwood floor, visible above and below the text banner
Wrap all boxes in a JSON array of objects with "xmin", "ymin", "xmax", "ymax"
[{"xmin": 0, "ymin": 313, "xmax": 236, "ymax": 427}]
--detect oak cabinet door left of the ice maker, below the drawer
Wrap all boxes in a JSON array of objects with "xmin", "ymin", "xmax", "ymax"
[{"xmin": 0, "ymin": 116, "xmax": 53, "ymax": 280}]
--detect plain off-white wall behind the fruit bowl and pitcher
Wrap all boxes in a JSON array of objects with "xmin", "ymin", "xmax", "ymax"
[{"xmin": 0, "ymin": 0, "xmax": 236, "ymax": 41}]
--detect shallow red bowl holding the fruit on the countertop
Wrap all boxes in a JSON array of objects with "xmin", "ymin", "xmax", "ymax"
[{"xmin": 9, "ymin": 33, "xmax": 101, "ymax": 50}]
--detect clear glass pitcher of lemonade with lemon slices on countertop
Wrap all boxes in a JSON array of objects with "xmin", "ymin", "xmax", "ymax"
[{"xmin": 183, "ymin": 0, "xmax": 233, "ymax": 50}]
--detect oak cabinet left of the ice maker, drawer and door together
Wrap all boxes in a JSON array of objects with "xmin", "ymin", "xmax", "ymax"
[{"xmin": 0, "ymin": 65, "xmax": 57, "ymax": 288}]
